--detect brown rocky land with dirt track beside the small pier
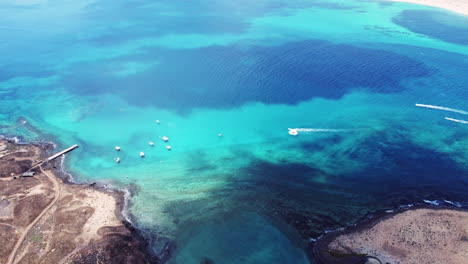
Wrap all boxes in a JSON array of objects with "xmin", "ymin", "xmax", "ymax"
[{"xmin": 0, "ymin": 140, "xmax": 158, "ymax": 264}]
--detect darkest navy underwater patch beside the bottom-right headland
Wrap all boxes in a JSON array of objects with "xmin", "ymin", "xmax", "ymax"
[{"xmin": 245, "ymin": 134, "xmax": 468, "ymax": 260}]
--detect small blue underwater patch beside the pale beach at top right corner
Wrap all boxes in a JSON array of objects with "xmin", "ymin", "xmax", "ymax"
[{"xmin": 393, "ymin": 10, "xmax": 468, "ymax": 45}]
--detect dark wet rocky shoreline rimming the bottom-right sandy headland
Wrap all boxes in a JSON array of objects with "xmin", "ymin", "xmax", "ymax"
[{"xmin": 313, "ymin": 203, "xmax": 468, "ymax": 264}]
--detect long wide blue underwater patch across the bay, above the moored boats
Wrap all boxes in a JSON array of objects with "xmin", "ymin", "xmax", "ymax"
[{"xmin": 63, "ymin": 41, "xmax": 432, "ymax": 112}]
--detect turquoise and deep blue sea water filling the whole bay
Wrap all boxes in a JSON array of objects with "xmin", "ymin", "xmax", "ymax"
[{"xmin": 0, "ymin": 0, "xmax": 468, "ymax": 264}]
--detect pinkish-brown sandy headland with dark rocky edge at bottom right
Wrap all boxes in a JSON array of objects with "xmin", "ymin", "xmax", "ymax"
[{"xmin": 317, "ymin": 208, "xmax": 468, "ymax": 264}]
